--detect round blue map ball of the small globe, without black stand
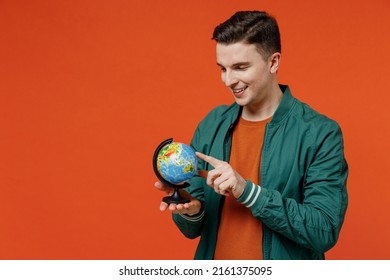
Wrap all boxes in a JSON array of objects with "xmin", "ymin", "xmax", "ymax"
[{"xmin": 156, "ymin": 142, "xmax": 198, "ymax": 185}]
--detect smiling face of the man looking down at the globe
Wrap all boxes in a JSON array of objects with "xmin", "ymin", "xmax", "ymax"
[{"xmin": 216, "ymin": 42, "xmax": 278, "ymax": 109}]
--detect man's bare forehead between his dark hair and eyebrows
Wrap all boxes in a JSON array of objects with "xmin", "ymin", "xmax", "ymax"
[{"xmin": 216, "ymin": 42, "xmax": 263, "ymax": 67}]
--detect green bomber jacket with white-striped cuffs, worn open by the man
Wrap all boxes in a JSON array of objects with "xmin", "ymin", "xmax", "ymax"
[{"xmin": 172, "ymin": 85, "xmax": 348, "ymax": 260}]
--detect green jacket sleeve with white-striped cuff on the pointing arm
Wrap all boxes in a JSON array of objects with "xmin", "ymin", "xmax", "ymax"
[{"xmin": 238, "ymin": 122, "xmax": 348, "ymax": 253}]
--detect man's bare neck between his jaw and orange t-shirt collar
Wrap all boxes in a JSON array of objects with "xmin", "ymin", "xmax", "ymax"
[{"xmin": 242, "ymin": 84, "xmax": 283, "ymax": 121}]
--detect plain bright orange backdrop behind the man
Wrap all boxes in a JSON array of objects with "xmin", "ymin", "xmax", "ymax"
[{"xmin": 0, "ymin": 0, "xmax": 390, "ymax": 259}]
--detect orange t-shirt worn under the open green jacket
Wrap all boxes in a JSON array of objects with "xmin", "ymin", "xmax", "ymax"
[{"xmin": 214, "ymin": 118, "xmax": 271, "ymax": 260}]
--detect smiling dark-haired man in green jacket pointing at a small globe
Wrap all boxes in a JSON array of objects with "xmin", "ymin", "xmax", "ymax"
[{"xmin": 155, "ymin": 11, "xmax": 348, "ymax": 259}]
